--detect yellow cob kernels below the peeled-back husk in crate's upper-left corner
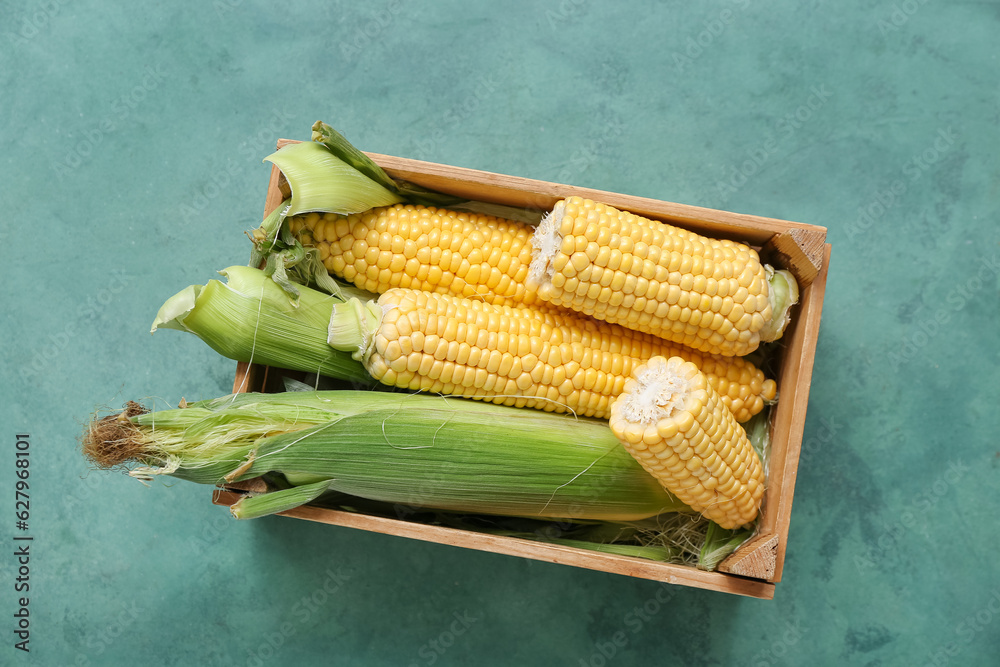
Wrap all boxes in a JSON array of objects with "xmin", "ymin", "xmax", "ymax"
[{"xmin": 289, "ymin": 204, "xmax": 536, "ymax": 305}]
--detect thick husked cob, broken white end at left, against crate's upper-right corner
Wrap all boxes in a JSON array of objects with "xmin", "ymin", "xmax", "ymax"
[{"xmin": 528, "ymin": 197, "xmax": 797, "ymax": 356}]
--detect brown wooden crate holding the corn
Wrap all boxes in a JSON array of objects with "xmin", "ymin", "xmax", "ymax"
[{"xmin": 213, "ymin": 140, "xmax": 830, "ymax": 599}]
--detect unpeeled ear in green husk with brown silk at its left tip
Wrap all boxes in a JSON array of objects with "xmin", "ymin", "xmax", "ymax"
[{"xmin": 84, "ymin": 391, "xmax": 689, "ymax": 521}]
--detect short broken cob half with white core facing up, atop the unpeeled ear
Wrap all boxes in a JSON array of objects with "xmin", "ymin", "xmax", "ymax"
[{"xmin": 609, "ymin": 357, "xmax": 764, "ymax": 528}]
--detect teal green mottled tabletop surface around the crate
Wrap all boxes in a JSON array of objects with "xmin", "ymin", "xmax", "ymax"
[{"xmin": 0, "ymin": 0, "xmax": 1000, "ymax": 667}]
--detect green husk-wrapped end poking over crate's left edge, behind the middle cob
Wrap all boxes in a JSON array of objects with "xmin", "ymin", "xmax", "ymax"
[{"xmin": 151, "ymin": 266, "xmax": 377, "ymax": 386}]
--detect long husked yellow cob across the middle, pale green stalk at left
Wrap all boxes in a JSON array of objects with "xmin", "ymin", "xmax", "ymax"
[{"xmin": 328, "ymin": 288, "xmax": 776, "ymax": 420}]
